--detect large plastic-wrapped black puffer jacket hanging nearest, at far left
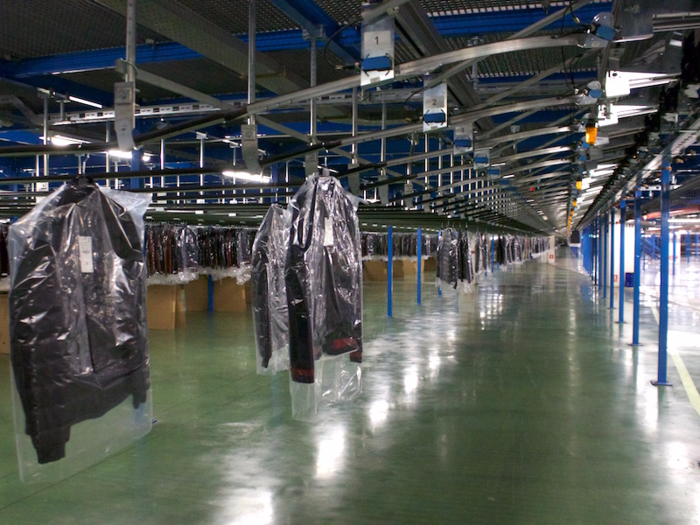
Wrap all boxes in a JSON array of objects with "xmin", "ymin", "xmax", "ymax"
[{"xmin": 9, "ymin": 180, "xmax": 150, "ymax": 463}]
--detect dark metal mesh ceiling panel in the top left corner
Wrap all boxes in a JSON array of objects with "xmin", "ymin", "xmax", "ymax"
[{"xmin": 0, "ymin": 0, "xmax": 167, "ymax": 60}]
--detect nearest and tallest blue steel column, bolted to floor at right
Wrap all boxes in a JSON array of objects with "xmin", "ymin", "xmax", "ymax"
[{"xmin": 652, "ymin": 157, "xmax": 671, "ymax": 386}]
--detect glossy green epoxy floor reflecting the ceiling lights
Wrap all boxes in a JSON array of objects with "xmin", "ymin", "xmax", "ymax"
[{"xmin": 0, "ymin": 252, "xmax": 700, "ymax": 525}]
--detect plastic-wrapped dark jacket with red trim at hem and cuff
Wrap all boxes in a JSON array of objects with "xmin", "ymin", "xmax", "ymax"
[{"xmin": 285, "ymin": 175, "xmax": 362, "ymax": 383}]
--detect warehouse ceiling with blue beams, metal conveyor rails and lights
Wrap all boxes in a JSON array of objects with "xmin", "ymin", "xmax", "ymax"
[{"xmin": 0, "ymin": 0, "xmax": 700, "ymax": 236}]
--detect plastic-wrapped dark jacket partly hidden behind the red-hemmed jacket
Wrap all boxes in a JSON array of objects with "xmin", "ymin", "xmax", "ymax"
[{"xmin": 251, "ymin": 204, "xmax": 289, "ymax": 374}]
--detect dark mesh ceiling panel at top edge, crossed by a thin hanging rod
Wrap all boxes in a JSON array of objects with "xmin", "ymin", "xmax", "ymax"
[{"xmin": 179, "ymin": 0, "xmax": 300, "ymax": 35}]
